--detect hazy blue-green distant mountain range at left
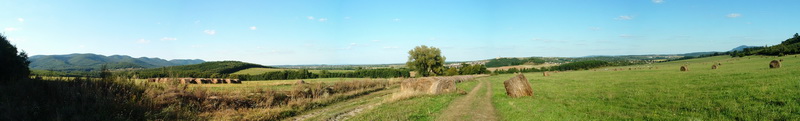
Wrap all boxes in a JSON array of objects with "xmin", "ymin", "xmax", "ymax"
[{"xmin": 28, "ymin": 54, "xmax": 205, "ymax": 71}]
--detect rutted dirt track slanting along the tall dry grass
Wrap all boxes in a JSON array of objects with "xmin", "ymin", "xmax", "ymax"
[{"xmin": 287, "ymin": 88, "xmax": 398, "ymax": 121}]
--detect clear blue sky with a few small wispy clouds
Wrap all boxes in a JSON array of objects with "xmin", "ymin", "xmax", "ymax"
[{"xmin": 0, "ymin": 0, "xmax": 800, "ymax": 65}]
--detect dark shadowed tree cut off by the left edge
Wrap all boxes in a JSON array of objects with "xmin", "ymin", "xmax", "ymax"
[{"xmin": 0, "ymin": 35, "xmax": 31, "ymax": 84}]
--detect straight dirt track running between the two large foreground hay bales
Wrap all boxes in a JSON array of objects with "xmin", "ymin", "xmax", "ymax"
[{"xmin": 436, "ymin": 80, "xmax": 497, "ymax": 121}]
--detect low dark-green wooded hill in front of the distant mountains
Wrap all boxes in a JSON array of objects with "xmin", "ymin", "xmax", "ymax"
[{"xmin": 135, "ymin": 61, "xmax": 273, "ymax": 77}]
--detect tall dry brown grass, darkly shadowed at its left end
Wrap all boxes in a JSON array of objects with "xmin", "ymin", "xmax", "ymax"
[{"xmin": 0, "ymin": 75, "xmax": 388, "ymax": 120}]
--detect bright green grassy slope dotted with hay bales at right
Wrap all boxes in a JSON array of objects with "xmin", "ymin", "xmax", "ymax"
[{"xmin": 487, "ymin": 55, "xmax": 800, "ymax": 120}]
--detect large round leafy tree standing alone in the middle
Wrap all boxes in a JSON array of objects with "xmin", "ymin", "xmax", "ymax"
[{"xmin": 406, "ymin": 45, "xmax": 445, "ymax": 76}]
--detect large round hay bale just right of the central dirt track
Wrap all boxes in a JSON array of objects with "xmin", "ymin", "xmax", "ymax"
[{"xmin": 503, "ymin": 74, "xmax": 533, "ymax": 98}]
